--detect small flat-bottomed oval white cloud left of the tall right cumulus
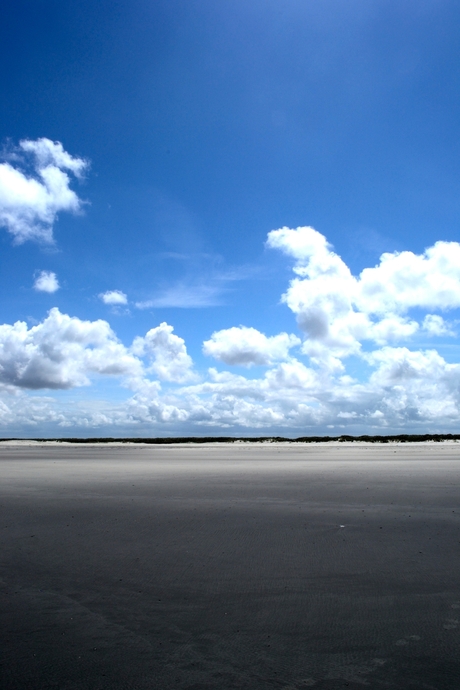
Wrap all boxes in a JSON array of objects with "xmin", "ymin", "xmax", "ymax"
[{"xmin": 203, "ymin": 326, "xmax": 301, "ymax": 367}]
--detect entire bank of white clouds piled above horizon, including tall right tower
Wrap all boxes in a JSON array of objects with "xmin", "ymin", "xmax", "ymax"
[{"xmin": 0, "ymin": 226, "xmax": 460, "ymax": 435}]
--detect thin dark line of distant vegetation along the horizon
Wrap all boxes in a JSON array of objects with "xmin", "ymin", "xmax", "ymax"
[{"xmin": 1, "ymin": 434, "xmax": 460, "ymax": 445}]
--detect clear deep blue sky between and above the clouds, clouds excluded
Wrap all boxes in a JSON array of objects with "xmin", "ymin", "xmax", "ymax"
[{"xmin": 0, "ymin": 0, "xmax": 460, "ymax": 433}]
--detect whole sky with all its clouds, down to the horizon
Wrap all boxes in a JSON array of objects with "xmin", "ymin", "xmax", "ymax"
[{"xmin": 0, "ymin": 0, "xmax": 460, "ymax": 438}]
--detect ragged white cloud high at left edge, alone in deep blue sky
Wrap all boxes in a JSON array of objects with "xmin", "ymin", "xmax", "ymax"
[{"xmin": 0, "ymin": 138, "xmax": 88, "ymax": 244}]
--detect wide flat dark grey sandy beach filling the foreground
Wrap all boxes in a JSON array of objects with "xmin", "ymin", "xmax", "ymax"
[{"xmin": 0, "ymin": 444, "xmax": 460, "ymax": 690}]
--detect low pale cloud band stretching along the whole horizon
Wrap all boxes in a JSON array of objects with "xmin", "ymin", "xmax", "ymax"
[{"xmin": 6, "ymin": 347, "xmax": 460, "ymax": 435}]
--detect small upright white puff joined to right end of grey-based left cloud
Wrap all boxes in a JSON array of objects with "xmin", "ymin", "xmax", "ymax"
[{"xmin": 132, "ymin": 322, "xmax": 195, "ymax": 382}]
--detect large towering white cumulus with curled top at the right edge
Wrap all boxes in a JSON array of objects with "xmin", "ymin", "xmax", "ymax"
[{"xmin": 267, "ymin": 227, "xmax": 460, "ymax": 369}]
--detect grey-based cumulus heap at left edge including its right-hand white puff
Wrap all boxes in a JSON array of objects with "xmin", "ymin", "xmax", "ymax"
[{"xmin": 0, "ymin": 307, "xmax": 196, "ymax": 397}]
